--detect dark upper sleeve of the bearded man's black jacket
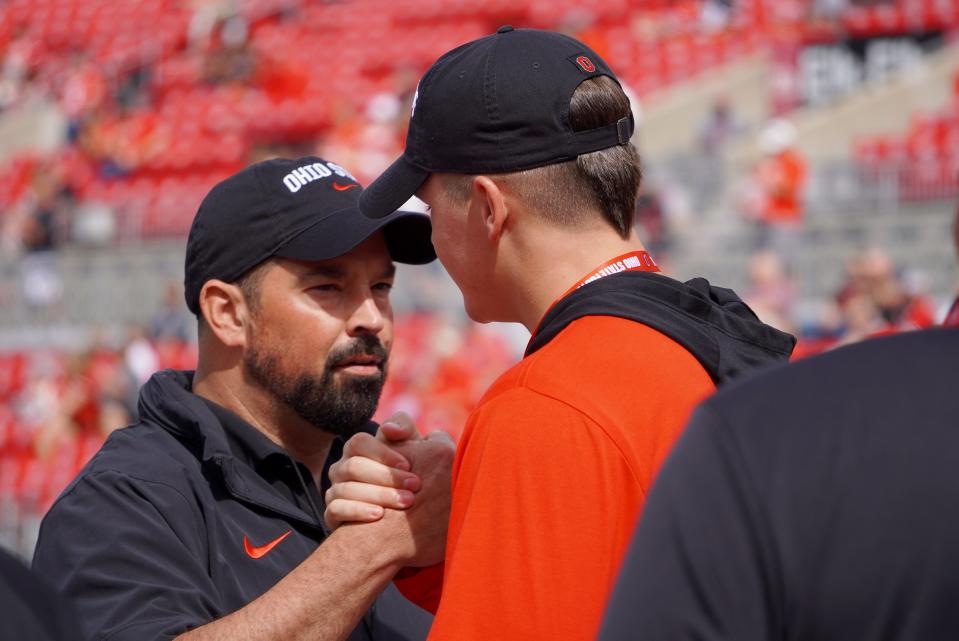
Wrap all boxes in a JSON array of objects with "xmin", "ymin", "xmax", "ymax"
[{"xmin": 33, "ymin": 472, "xmax": 217, "ymax": 641}]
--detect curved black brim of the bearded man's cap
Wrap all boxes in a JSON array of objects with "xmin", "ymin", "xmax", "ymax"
[{"xmin": 274, "ymin": 207, "xmax": 436, "ymax": 265}]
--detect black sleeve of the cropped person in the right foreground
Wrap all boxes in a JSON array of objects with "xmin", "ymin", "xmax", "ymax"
[{"xmin": 599, "ymin": 403, "xmax": 780, "ymax": 641}]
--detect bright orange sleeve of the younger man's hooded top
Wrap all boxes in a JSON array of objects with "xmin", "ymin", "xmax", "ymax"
[{"xmin": 429, "ymin": 388, "xmax": 643, "ymax": 641}]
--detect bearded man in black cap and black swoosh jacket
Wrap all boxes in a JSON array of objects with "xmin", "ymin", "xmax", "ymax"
[{"xmin": 33, "ymin": 158, "xmax": 450, "ymax": 641}]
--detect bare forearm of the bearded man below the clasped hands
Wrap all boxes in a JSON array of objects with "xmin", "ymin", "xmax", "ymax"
[{"xmin": 174, "ymin": 524, "xmax": 401, "ymax": 641}]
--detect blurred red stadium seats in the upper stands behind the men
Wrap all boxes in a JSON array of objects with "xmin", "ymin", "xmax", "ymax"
[{"xmin": 0, "ymin": 0, "xmax": 959, "ymax": 237}]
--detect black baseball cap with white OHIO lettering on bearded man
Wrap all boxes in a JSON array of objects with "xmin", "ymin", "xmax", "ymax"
[{"xmin": 184, "ymin": 156, "xmax": 436, "ymax": 315}]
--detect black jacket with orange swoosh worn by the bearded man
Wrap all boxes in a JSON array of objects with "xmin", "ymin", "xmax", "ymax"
[{"xmin": 33, "ymin": 370, "xmax": 431, "ymax": 641}]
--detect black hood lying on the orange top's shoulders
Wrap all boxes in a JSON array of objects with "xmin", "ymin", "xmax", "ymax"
[{"xmin": 526, "ymin": 271, "xmax": 796, "ymax": 385}]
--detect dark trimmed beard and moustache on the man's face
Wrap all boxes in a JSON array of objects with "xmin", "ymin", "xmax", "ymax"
[{"xmin": 243, "ymin": 334, "xmax": 388, "ymax": 438}]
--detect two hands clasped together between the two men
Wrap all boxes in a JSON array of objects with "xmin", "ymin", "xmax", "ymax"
[{"xmin": 324, "ymin": 413, "xmax": 456, "ymax": 567}]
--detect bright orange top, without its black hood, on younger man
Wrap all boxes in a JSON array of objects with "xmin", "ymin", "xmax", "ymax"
[{"xmin": 398, "ymin": 316, "xmax": 714, "ymax": 641}]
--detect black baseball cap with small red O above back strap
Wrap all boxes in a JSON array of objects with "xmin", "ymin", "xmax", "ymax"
[{"xmin": 360, "ymin": 26, "xmax": 634, "ymax": 218}]
